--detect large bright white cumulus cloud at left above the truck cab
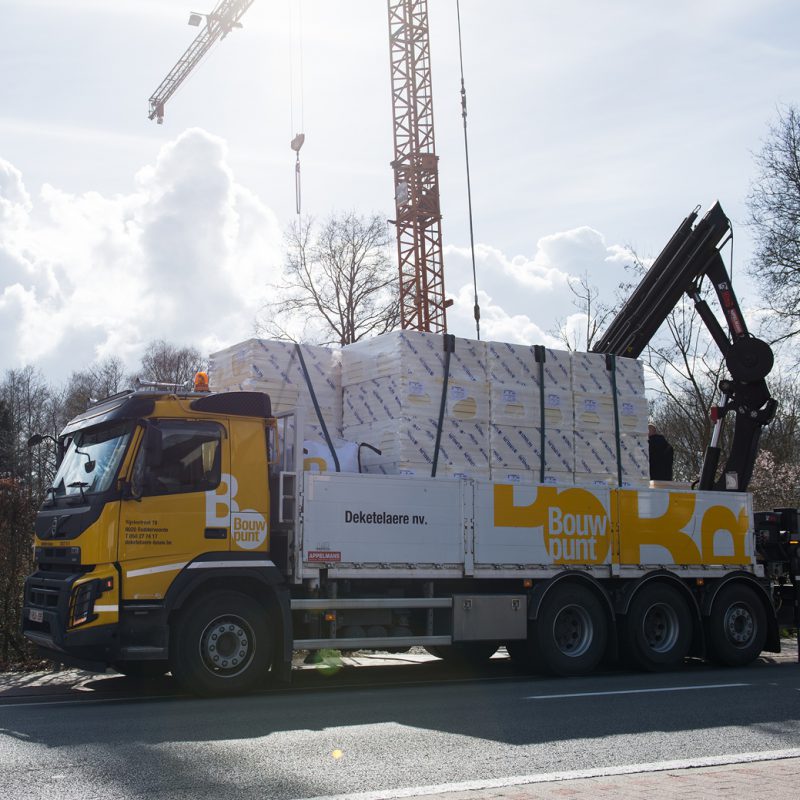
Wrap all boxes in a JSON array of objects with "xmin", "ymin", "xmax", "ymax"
[{"xmin": 0, "ymin": 129, "xmax": 281, "ymax": 377}]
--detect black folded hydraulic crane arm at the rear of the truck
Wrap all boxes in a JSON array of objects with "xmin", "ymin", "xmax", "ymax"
[{"xmin": 592, "ymin": 203, "xmax": 777, "ymax": 491}]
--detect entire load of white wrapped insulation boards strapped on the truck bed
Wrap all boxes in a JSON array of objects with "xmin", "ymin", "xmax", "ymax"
[{"xmin": 210, "ymin": 331, "xmax": 649, "ymax": 486}]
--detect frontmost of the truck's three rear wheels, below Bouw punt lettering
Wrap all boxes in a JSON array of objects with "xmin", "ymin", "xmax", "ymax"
[{"xmin": 530, "ymin": 584, "xmax": 608, "ymax": 675}]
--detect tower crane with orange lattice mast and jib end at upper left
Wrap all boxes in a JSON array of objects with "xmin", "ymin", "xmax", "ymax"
[{"xmin": 148, "ymin": 0, "xmax": 452, "ymax": 333}]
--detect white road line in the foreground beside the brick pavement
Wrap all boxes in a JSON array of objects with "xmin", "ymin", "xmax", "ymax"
[{"xmin": 304, "ymin": 748, "xmax": 800, "ymax": 800}]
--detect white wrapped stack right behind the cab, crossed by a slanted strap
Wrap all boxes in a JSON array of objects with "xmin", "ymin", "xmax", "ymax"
[{"xmin": 209, "ymin": 339, "xmax": 342, "ymax": 442}]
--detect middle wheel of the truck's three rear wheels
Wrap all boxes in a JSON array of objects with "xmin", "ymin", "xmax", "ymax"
[{"xmin": 623, "ymin": 584, "xmax": 692, "ymax": 672}]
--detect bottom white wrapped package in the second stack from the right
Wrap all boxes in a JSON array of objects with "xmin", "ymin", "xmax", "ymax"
[{"xmin": 489, "ymin": 423, "xmax": 575, "ymax": 473}]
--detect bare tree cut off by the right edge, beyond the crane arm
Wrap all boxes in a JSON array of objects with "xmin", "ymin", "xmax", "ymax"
[{"xmin": 747, "ymin": 106, "xmax": 800, "ymax": 339}]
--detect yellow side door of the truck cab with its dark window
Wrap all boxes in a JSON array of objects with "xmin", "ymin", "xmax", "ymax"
[{"xmin": 118, "ymin": 419, "xmax": 230, "ymax": 600}]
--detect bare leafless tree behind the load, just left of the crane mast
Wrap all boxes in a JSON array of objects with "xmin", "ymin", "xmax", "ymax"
[{"xmin": 257, "ymin": 211, "xmax": 400, "ymax": 345}]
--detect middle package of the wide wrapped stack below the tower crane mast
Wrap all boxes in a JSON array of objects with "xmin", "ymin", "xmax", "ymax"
[{"xmin": 342, "ymin": 375, "xmax": 489, "ymax": 426}]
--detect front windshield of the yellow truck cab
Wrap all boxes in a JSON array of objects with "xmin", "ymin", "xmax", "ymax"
[{"xmin": 52, "ymin": 421, "xmax": 134, "ymax": 498}]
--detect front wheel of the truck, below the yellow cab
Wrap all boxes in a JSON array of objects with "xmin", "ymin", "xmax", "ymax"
[{"xmin": 171, "ymin": 591, "xmax": 273, "ymax": 696}]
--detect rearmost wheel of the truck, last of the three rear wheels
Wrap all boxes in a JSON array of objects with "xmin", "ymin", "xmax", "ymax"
[{"xmin": 707, "ymin": 584, "xmax": 767, "ymax": 667}]
